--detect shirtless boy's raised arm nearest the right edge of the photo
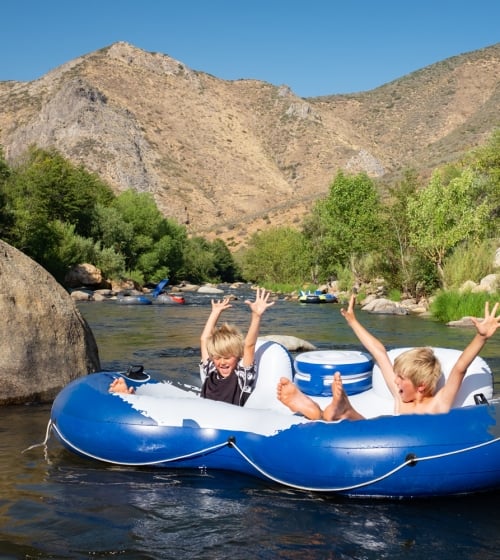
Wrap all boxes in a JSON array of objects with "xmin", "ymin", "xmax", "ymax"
[{"xmin": 436, "ymin": 302, "xmax": 500, "ymax": 412}]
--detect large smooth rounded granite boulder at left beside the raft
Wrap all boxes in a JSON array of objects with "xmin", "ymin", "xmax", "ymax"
[{"xmin": 0, "ymin": 240, "xmax": 100, "ymax": 404}]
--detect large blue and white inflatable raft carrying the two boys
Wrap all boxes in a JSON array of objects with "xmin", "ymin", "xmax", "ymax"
[{"xmin": 50, "ymin": 341, "xmax": 500, "ymax": 498}]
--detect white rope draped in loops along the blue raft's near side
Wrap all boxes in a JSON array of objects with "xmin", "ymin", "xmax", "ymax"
[{"xmin": 23, "ymin": 420, "xmax": 500, "ymax": 493}]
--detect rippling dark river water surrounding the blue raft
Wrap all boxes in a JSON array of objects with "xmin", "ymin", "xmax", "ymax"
[{"xmin": 0, "ymin": 293, "xmax": 500, "ymax": 560}]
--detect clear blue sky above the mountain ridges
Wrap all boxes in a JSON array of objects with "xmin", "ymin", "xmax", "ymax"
[{"xmin": 0, "ymin": 0, "xmax": 500, "ymax": 97}]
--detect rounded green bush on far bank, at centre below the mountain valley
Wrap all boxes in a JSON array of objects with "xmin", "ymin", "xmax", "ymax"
[{"xmin": 242, "ymin": 227, "xmax": 312, "ymax": 285}]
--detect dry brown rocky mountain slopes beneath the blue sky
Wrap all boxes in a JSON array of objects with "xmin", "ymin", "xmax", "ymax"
[{"xmin": 0, "ymin": 42, "xmax": 500, "ymax": 249}]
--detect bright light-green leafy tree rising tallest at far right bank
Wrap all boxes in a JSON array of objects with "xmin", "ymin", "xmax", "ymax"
[{"xmin": 407, "ymin": 169, "xmax": 491, "ymax": 279}]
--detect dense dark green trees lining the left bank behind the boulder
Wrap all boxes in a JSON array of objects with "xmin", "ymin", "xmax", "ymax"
[{"xmin": 0, "ymin": 148, "xmax": 236, "ymax": 284}]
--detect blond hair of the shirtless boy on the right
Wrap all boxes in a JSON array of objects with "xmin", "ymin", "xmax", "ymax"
[{"xmin": 394, "ymin": 347, "xmax": 442, "ymax": 396}]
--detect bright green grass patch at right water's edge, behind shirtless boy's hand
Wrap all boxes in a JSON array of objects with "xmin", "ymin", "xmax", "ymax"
[{"xmin": 430, "ymin": 291, "xmax": 499, "ymax": 323}]
